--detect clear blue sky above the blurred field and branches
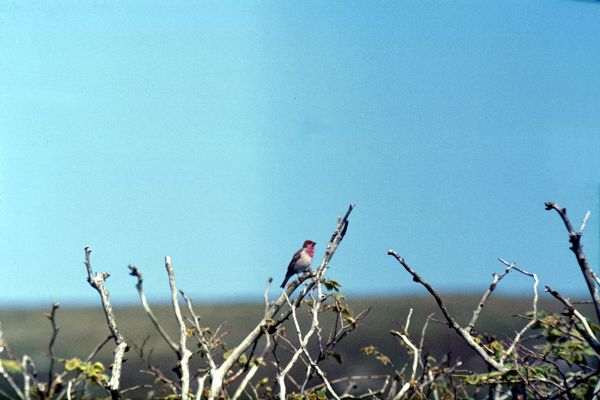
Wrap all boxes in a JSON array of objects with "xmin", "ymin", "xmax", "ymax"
[{"xmin": 0, "ymin": 0, "xmax": 600, "ymax": 305}]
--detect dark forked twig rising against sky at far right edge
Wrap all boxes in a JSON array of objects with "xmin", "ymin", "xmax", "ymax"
[{"xmin": 545, "ymin": 201, "xmax": 600, "ymax": 322}]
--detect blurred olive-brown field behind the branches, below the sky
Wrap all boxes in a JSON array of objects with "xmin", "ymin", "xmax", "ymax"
[{"xmin": 0, "ymin": 294, "xmax": 584, "ymax": 396}]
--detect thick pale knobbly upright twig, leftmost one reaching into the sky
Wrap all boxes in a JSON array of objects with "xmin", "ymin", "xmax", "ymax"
[{"xmin": 84, "ymin": 246, "xmax": 128, "ymax": 400}]
